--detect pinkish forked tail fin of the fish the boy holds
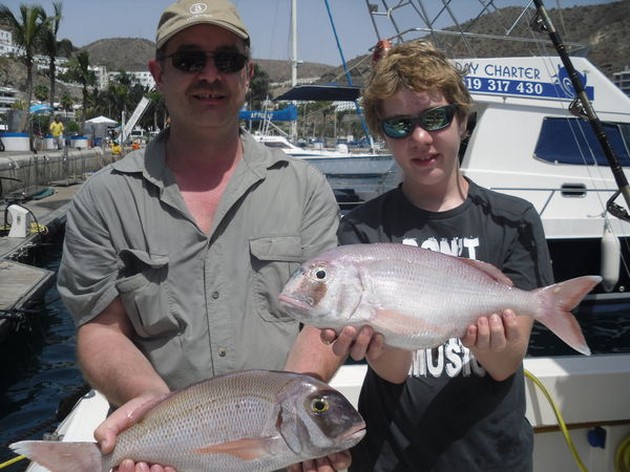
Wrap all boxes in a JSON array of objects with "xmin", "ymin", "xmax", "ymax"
[{"xmin": 536, "ymin": 275, "xmax": 602, "ymax": 356}]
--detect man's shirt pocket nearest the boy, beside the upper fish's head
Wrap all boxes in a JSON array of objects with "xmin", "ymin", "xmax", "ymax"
[{"xmin": 249, "ymin": 235, "xmax": 303, "ymax": 322}]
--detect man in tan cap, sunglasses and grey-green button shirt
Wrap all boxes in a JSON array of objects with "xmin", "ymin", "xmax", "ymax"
[{"xmin": 58, "ymin": 0, "xmax": 350, "ymax": 472}]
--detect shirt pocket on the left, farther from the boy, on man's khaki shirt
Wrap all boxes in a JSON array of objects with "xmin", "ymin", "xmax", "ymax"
[{"xmin": 116, "ymin": 249, "xmax": 181, "ymax": 338}]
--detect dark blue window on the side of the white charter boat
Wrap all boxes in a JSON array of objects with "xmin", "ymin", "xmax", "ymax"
[{"xmin": 534, "ymin": 117, "xmax": 630, "ymax": 167}]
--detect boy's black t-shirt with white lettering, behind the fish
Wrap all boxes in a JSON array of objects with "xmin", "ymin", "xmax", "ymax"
[{"xmin": 339, "ymin": 181, "xmax": 553, "ymax": 472}]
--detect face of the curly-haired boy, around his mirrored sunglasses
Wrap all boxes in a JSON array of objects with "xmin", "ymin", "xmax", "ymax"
[{"xmin": 380, "ymin": 88, "xmax": 466, "ymax": 197}]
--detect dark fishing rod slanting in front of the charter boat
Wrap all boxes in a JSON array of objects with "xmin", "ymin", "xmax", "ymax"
[{"xmin": 531, "ymin": 0, "xmax": 630, "ymax": 221}]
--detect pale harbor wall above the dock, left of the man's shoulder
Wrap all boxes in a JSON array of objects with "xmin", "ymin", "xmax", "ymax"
[{"xmin": 0, "ymin": 147, "xmax": 119, "ymax": 199}]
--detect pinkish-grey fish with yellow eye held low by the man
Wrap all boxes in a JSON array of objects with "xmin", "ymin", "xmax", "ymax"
[{"xmin": 10, "ymin": 371, "xmax": 365, "ymax": 472}]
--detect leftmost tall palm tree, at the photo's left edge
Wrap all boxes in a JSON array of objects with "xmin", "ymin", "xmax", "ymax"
[{"xmin": 0, "ymin": 5, "xmax": 46, "ymax": 131}]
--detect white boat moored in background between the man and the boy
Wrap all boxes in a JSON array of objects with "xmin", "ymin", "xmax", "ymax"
[{"xmin": 254, "ymin": 134, "xmax": 396, "ymax": 178}]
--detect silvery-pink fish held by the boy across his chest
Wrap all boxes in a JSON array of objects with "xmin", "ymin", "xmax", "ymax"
[{"xmin": 279, "ymin": 243, "xmax": 601, "ymax": 355}]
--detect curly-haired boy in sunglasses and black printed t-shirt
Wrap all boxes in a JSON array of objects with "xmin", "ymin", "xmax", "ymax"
[{"xmin": 330, "ymin": 41, "xmax": 553, "ymax": 472}]
